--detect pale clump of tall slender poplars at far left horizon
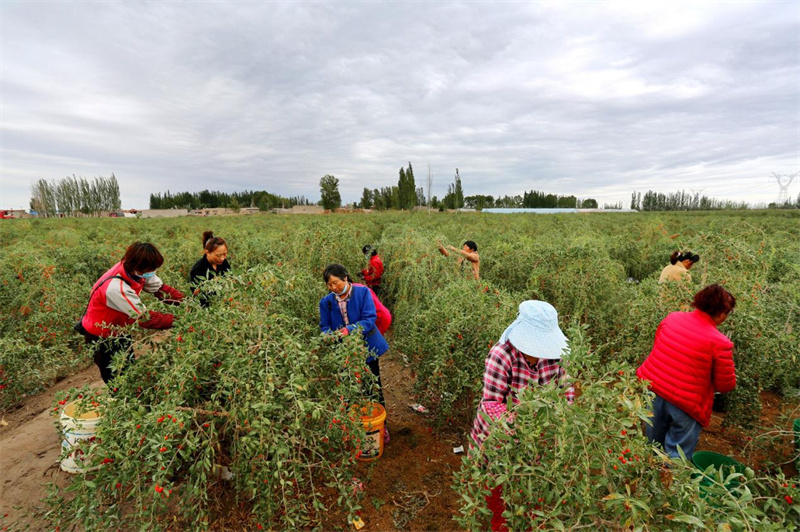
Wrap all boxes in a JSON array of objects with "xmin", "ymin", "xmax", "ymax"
[{"xmin": 30, "ymin": 174, "xmax": 122, "ymax": 218}]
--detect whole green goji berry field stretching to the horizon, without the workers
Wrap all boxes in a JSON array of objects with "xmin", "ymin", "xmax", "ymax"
[{"xmin": 0, "ymin": 211, "xmax": 800, "ymax": 530}]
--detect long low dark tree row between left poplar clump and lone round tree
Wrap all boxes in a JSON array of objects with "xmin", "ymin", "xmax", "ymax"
[{"xmin": 150, "ymin": 190, "xmax": 311, "ymax": 211}]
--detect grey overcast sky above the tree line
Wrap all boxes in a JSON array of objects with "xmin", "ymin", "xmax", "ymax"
[{"xmin": 0, "ymin": 0, "xmax": 800, "ymax": 208}]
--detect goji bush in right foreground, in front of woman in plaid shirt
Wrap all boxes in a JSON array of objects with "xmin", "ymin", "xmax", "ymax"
[{"xmin": 453, "ymin": 327, "xmax": 800, "ymax": 531}]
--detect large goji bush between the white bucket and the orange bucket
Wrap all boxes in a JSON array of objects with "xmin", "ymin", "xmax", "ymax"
[{"xmin": 45, "ymin": 266, "xmax": 371, "ymax": 530}]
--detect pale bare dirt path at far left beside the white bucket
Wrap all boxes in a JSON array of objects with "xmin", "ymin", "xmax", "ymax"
[{"xmin": 0, "ymin": 365, "xmax": 103, "ymax": 530}]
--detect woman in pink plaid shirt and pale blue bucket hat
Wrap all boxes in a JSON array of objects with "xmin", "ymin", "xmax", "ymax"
[{"xmin": 470, "ymin": 301, "xmax": 575, "ymax": 530}]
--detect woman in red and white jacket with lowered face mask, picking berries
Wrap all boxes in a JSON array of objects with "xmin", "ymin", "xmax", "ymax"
[{"xmin": 80, "ymin": 242, "xmax": 183, "ymax": 384}]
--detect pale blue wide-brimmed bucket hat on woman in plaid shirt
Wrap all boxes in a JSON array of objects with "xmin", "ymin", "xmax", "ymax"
[{"xmin": 500, "ymin": 300, "xmax": 569, "ymax": 360}]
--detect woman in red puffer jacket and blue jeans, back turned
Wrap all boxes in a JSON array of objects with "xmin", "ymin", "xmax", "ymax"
[{"xmin": 636, "ymin": 284, "xmax": 736, "ymax": 459}]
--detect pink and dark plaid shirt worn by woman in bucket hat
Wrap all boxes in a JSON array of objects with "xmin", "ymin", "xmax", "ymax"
[{"xmin": 470, "ymin": 342, "xmax": 575, "ymax": 447}]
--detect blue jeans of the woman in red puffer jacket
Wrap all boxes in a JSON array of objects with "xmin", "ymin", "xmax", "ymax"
[{"xmin": 645, "ymin": 395, "xmax": 703, "ymax": 460}]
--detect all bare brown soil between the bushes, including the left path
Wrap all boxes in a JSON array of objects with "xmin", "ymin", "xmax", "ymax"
[{"xmin": 0, "ymin": 360, "xmax": 797, "ymax": 532}]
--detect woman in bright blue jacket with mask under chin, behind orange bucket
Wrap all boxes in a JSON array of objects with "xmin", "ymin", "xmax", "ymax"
[{"xmin": 319, "ymin": 264, "xmax": 389, "ymax": 443}]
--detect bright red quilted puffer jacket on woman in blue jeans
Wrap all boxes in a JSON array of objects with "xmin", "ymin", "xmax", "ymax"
[{"xmin": 636, "ymin": 310, "xmax": 736, "ymax": 427}]
